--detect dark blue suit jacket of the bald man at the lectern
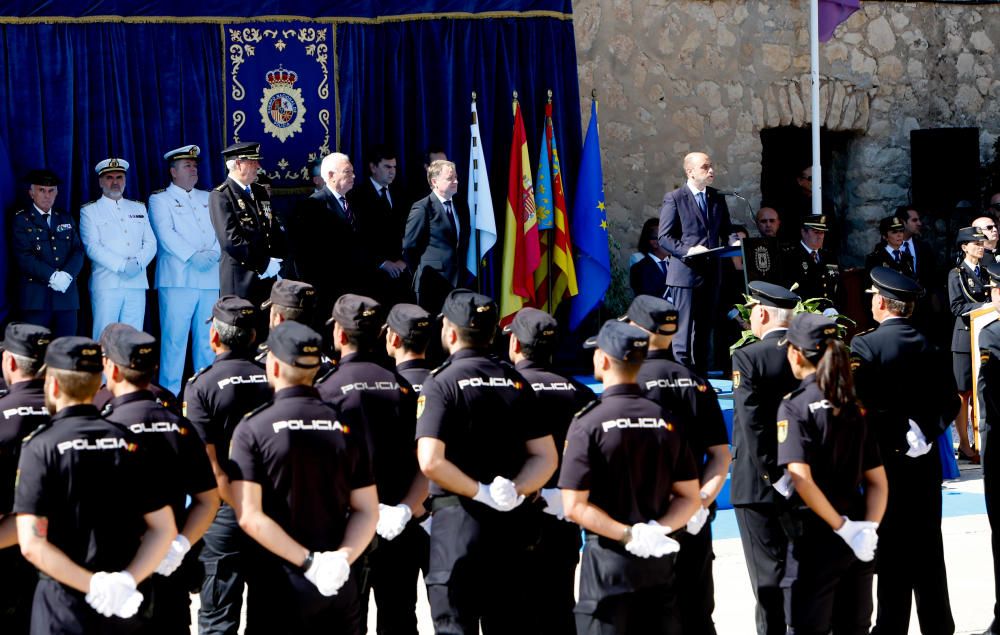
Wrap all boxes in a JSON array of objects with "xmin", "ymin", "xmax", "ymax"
[{"xmin": 659, "ymin": 183, "xmax": 732, "ymax": 287}]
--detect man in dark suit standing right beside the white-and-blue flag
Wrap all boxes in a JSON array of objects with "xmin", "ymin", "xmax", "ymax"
[{"xmin": 403, "ymin": 160, "xmax": 469, "ymax": 314}]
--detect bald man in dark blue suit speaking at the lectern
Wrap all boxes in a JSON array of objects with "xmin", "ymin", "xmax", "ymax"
[{"xmin": 659, "ymin": 152, "xmax": 733, "ymax": 375}]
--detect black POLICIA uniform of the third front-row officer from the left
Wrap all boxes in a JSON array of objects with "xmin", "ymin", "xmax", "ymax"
[{"xmin": 416, "ymin": 348, "xmax": 549, "ymax": 634}]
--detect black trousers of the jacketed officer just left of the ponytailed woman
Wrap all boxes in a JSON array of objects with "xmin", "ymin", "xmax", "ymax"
[{"xmin": 733, "ymin": 503, "xmax": 788, "ymax": 635}]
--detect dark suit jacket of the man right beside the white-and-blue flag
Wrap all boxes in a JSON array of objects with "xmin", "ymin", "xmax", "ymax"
[{"xmin": 403, "ymin": 192, "xmax": 469, "ymax": 311}]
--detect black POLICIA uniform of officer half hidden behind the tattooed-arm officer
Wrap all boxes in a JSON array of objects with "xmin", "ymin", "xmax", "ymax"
[{"xmin": 101, "ymin": 390, "xmax": 216, "ymax": 635}]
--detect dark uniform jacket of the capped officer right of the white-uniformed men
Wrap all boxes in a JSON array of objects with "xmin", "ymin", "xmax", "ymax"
[{"xmin": 208, "ymin": 178, "xmax": 285, "ymax": 305}]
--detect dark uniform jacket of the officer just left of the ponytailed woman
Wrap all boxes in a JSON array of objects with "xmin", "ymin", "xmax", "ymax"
[{"xmin": 730, "ymin": 330, "xmax": 799, "ymax": 505}]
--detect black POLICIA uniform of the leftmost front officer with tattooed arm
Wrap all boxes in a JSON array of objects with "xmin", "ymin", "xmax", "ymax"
[{"xmin": 14, "ymin": 404, "xmax": 168, "ymax": 635}]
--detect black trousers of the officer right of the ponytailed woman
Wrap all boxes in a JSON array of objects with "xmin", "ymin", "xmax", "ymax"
[{"xmin": 872, "ymin": 452, "xmax": 955, "ymax": 635}]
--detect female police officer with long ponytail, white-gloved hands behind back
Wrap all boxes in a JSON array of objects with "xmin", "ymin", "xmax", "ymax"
[{"xmin": 777, "ymin": 313, "xmax": 888, "ymax": 635}]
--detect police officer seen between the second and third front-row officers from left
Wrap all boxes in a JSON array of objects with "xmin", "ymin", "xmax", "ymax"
[{"xmin": 316, "ymin": 293, "xmax": 428, "ymax": 634}]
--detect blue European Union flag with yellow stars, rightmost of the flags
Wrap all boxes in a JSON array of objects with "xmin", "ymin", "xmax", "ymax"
[{"xmin": 569, "ymin": 99, "xmax": 611, "ymax": 330}]
